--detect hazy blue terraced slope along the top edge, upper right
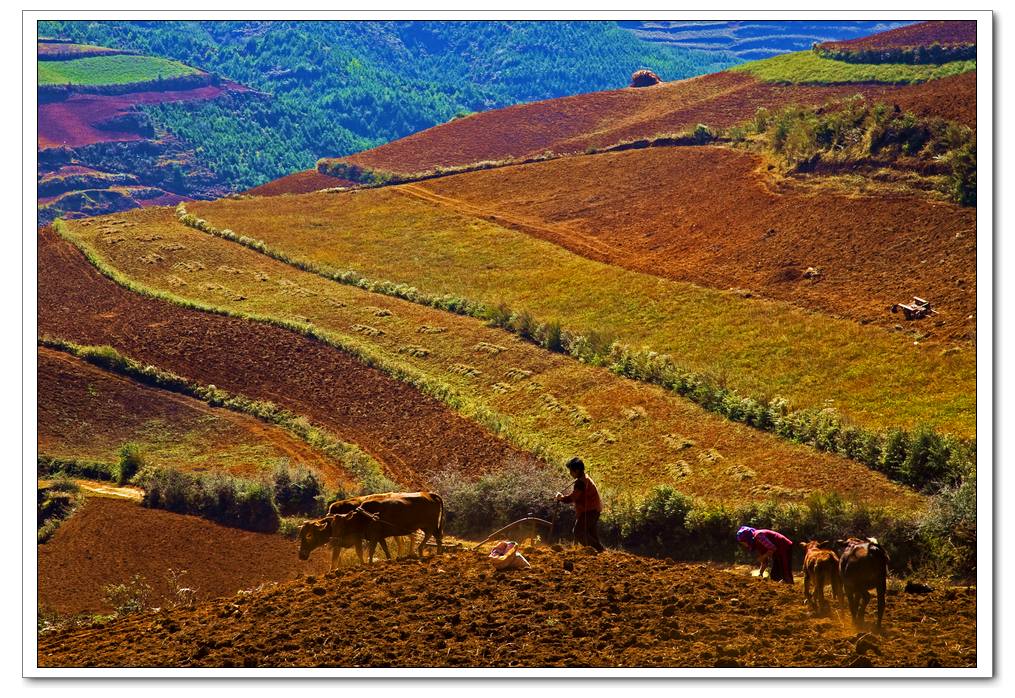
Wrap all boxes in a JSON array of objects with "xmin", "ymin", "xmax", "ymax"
[{"xmin": 617, "ymin": 20, "xmax": 907, "ymax": 60}]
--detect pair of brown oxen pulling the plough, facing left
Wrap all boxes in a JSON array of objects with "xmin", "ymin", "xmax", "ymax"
[{"xmin": 299, "ymin": 492, "xmax": 444, "ymax": 569}]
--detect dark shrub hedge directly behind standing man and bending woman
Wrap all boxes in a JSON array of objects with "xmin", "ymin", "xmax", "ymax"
[{"xmin": 434, "ymin": 460, "xmax": 976, "ymax": 579}]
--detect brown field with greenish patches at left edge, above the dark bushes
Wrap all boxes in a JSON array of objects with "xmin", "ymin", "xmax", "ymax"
[{"xmin": 38, "ymin": 347, "xmax": 356, "ymax": 488}]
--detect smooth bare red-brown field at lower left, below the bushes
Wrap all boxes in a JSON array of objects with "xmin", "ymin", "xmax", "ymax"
[{"xmin": 38, "ymin": 497, "xmax": 330, "ymax": 615}]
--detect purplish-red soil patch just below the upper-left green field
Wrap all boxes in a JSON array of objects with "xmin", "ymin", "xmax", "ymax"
[{"xmin": 38, "ymin": 83, "xmax": 233, "ymax": 148}]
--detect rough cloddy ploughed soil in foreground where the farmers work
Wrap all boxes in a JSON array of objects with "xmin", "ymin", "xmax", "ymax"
[{"xmin": 39, "ymin": 548, "xmax": 976, "ymax": 668}]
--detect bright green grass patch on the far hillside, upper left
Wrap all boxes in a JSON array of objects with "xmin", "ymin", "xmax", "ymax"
[{"xmin": 39, "ymin": 56, "xmax": 200, "ymax": 85}]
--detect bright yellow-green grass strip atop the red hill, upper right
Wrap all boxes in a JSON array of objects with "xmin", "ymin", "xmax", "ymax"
[{"xmin": 730, "ymin": 51, "xmax": 976, "ymax": 84}]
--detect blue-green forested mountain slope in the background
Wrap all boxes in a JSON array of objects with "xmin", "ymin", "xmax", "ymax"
[{"xmin": 40, "ymin": 21, "xmax": 737, "ymax": 189}]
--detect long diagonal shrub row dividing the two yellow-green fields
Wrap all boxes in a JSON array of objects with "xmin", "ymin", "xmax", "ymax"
[{"xmin": 177, "ymin": 204, "xmax": 975, "ymax": 491}]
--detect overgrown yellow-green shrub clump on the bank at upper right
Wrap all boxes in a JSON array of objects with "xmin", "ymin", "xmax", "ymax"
[{"xmin": 728, "ymin": 94, "xmax": 976, "ymax": 206}]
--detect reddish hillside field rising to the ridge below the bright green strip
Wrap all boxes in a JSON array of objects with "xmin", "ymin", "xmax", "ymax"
[{"xmin": 250, "ymin": 70, "xmax": 976, "ymax": 196}]
